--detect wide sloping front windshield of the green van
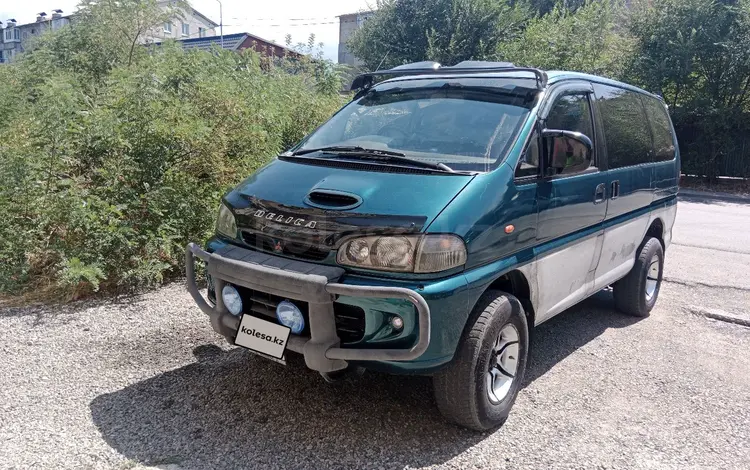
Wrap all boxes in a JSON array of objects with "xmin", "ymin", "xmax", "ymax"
[{"xmin": 295, "ymin": 78, "xmax": 537, "ymax": 171}]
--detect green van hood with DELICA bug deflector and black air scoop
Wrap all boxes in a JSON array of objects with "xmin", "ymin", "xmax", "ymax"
[{"xmin": 225, "ymin": 159, "xmax": 474, "ymax": 260}]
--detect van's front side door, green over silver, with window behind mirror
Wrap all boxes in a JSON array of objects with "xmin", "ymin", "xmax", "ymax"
[{"xmin": 536, "ymin": 82, "xmax": 607, "ymax": 321}]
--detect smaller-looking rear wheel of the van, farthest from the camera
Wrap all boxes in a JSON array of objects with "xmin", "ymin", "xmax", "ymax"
[{"xmin": 612, "ymin": 238, "xmax": 664, "ymax": 317}]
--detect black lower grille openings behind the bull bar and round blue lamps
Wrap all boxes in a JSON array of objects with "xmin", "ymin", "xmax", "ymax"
[{"xmin": 235, "ymin": 286, "xmax": 365, "ymax": 344}]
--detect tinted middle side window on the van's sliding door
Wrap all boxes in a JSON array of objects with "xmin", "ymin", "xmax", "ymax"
[{"xmin": 594, "ymin": 85, "xmax": 652, "ymax": 168}]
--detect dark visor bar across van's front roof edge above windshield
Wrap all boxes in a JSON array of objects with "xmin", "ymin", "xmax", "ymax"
[{"xmin": 351, "ymin": 60, "xmax": 547, "ymax": 90}]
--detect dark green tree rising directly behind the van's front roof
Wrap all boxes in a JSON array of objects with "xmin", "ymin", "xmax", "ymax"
[{"xmin": 348, "ymin": 0, "xmax": 527, "ymax": 70}]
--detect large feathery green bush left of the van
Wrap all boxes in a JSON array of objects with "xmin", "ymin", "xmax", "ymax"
[{"xmin": 0, "ymin": 2, "xmax": 341, "ymax": 297}]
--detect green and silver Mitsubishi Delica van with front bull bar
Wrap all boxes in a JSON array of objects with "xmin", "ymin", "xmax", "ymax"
[{"xmin": 186, "ymin": 62, "xmax": 680, "ymax": 430}]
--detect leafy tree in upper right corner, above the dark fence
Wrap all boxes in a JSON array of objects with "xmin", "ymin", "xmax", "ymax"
[{"xmin": 630, "ymin": 0, "xmax": 750, "ymax": 107}]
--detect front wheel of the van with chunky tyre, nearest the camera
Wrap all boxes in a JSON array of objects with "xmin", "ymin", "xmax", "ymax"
[{"xmin": 433, "ymin": 291, "xmax": 529, "ymax": 431}]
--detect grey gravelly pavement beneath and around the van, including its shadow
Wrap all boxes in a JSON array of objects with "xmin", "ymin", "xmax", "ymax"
[{"xmin": 0, "ymin": 196, "xmax": 750, "ymax": 469}]
